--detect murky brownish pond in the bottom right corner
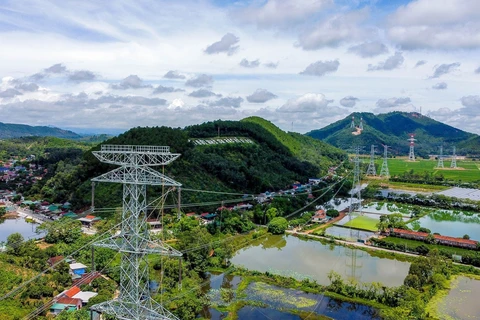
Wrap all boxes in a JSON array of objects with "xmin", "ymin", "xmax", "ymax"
[{"xmin": 437, "ymin": 277, "xmax": 480, "ymax": 320}]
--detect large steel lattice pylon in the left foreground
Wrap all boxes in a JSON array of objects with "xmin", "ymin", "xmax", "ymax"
[{"xmin": 91, "ymin": 145, "xmax": 182, "ymax": 320}]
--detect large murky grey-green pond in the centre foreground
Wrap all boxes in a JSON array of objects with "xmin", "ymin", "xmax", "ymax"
[{"xmin": 231, "ymin": 235, "xmax": 410, "ymax": 286}]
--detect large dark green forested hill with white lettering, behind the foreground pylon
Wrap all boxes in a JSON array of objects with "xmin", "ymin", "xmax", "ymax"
[{"xmin": 26, "ymin": 118, "xmax": 346, "ymax": 210}]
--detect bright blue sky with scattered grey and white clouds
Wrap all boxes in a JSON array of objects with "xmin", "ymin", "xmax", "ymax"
[{"xmin": 0, "ymin": 0, "xmax": 480, "ymax": 134}]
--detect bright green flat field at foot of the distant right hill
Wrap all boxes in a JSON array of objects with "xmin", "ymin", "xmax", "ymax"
[{"xmin": 376, "ymin": 159, "xmax": 480, "ymax": 182}]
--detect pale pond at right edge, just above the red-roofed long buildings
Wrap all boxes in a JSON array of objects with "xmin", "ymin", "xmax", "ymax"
[{"xmin": 408, "ymin": 210, "xmax": 480, "ymax": 241}]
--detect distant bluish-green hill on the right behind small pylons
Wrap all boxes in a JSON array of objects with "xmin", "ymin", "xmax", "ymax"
[{"xmin": 306, "ymin": 111, "xmax": 476, "ymax": 156}]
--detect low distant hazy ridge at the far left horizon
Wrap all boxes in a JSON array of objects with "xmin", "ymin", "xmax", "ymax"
[{"xmin": 0, "ymin": 122, "xmax": 81, "ymax": 139}]
